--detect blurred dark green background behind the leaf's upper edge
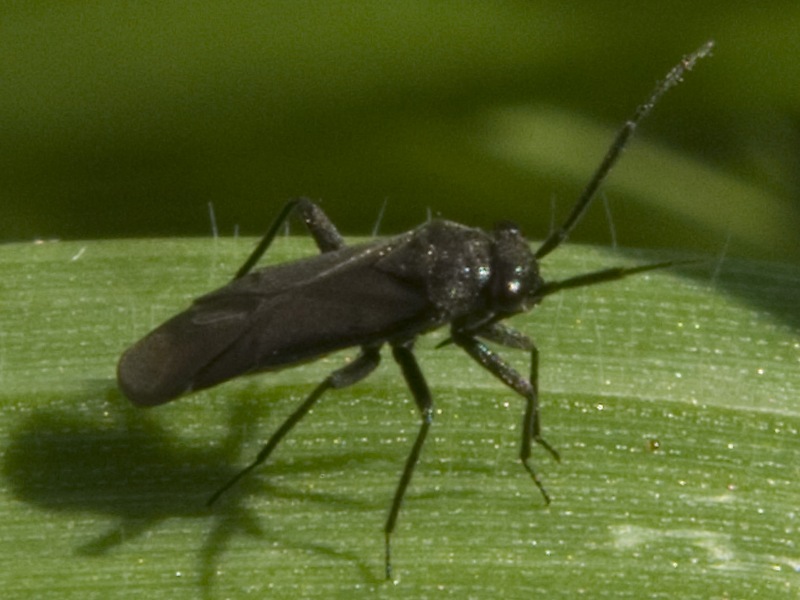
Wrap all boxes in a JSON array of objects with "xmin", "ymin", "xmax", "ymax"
[{"xmin": 0, "ymin": 0, "xmax": 800, "ymax": 263}]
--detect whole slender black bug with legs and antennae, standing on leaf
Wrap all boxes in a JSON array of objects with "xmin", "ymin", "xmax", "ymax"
[{"xmin": 117, "ymin": 42, "xmax": 713, "ymax": 578}]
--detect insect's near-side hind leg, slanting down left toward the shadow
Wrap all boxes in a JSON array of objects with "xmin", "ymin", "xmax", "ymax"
[{"xmin": 206, "ymin": 346, "xmax": 381, "ymax": 506}]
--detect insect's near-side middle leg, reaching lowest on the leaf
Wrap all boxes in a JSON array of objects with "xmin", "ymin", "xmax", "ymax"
[{"xmin": 384, "ymin": 344, "xmax": 433, "ymax": 579}]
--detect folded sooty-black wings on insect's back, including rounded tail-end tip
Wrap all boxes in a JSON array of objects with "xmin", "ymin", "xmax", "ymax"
[{"xmin": 118, "ymin": 237, "xmax": 430, "ymax": 406}]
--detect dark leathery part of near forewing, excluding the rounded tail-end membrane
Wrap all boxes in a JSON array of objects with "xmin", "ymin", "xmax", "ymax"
[{"xmin": 188, "ymin": 239, "xmax": 435, "ymax": 388}]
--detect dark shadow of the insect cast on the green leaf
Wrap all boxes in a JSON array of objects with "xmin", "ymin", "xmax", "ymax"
[{"xmin": 1, "ymin": 389, "xmax": 382, "ymax": 595}]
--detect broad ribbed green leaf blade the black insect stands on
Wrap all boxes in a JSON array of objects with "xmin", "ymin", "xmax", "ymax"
[{"xmin": 0, "ymin": 239, "xmax": 800, "ymax": 599}]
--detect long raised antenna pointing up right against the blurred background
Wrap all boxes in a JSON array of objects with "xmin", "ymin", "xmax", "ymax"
[{"xmin": 534, "ymin": 40, "xmax": 714, "ymax": 260}]
